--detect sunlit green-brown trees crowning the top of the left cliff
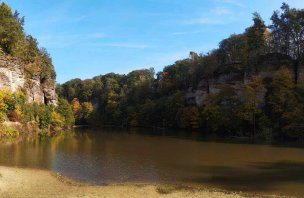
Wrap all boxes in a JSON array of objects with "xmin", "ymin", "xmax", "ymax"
[{"xmin": 0, "ymin": 3, "xmax": 56, "ymax": 82}]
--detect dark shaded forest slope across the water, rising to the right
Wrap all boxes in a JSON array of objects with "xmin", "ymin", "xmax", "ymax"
[{"xmin": 57, "ymin": 3, "xmax": 304, "ymax": 140}]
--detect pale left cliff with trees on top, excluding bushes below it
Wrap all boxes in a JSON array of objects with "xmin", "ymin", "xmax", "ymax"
[{"xmin": 0, "ymin": 3, "xmax": 57, "ymax": 105}]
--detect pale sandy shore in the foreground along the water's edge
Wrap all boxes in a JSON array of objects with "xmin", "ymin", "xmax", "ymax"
[{"xmin": 0, "ymin": 166, "xmax": 288, "ymax": 198}]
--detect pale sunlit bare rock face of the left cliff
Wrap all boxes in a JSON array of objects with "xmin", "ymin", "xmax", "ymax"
[{"xmin": 0, "ymin": 51, "xmax": 57, "ymax": 106}]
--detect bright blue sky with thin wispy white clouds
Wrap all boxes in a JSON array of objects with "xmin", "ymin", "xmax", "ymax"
[{"xmin": 3, "ymin": 0, "xmax": 304, "ymax": 83}]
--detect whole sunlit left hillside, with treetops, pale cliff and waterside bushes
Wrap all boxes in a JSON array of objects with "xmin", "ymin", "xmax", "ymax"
[{"xmin": 0, "ymin": 2, "xmax": 74, "ymax": 139}]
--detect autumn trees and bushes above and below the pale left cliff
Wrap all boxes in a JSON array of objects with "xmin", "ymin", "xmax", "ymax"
[{"xmin": 0, "ymin": 3, "xmax": 74, "ymax": 138}]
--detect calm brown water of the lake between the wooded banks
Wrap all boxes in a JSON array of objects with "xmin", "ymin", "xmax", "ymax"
[{"xmin": 0, "ymin": 129, "xmax": 304, "ymax": 196}]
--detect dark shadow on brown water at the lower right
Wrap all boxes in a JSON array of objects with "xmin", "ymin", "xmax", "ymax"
[{"xmin": 179, "ymin": 161, "xmax": 304, "ymax": 196}]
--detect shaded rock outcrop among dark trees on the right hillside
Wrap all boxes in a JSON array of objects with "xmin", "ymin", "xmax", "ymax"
[{"xmin": 186, "ymin": 54, "xmax": 296, "ymax": 106}]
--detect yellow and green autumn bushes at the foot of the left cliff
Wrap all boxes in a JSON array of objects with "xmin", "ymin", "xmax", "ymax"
[{"xmin": 0, "ymin": 89, "xmax": 74, "ymax": 138}]
